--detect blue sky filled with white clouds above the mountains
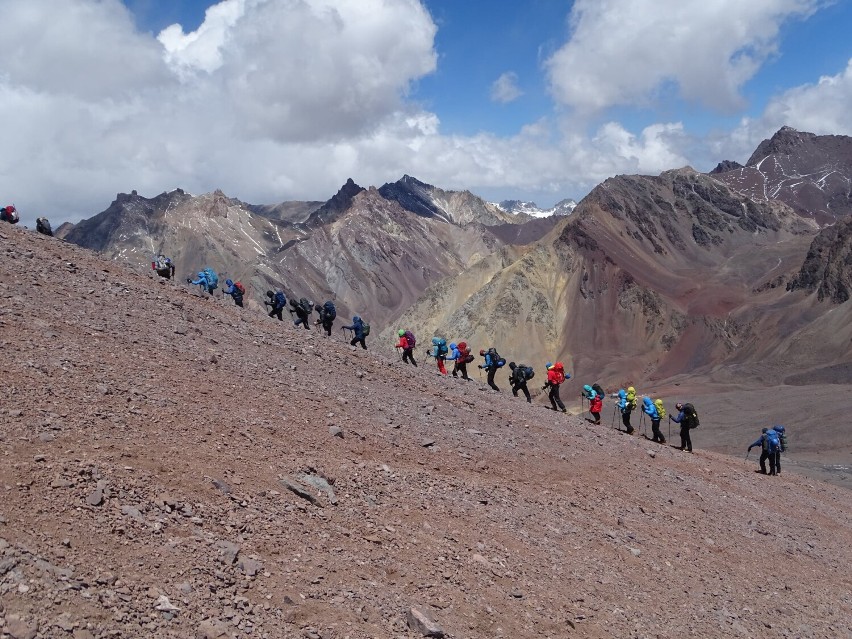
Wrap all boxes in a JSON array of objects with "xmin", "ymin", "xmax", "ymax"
[{"xmin": 0, "ymin": 0, "xmax": 852, "ymax": 221}]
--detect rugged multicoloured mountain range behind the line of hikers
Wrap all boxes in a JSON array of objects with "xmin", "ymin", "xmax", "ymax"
[{"xmin": 62, "ymin": 127, "xmax": 852, "ymax": 386}]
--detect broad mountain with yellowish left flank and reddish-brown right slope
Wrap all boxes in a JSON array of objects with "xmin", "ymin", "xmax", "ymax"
[{"xmin": 392, "ymin": 165, "xmax": 852, "ymax": 388}]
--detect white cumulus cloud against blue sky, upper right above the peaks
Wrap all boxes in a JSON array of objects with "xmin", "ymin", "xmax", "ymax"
[{"xmin": 546, "ymin": 0, "xmax": 823, "ymax": 113}]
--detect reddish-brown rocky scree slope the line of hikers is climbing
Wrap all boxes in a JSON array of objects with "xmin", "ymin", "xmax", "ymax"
[{"xmin": 0, "ymin": 226, "xmax": 852, "ymax": 639}]
